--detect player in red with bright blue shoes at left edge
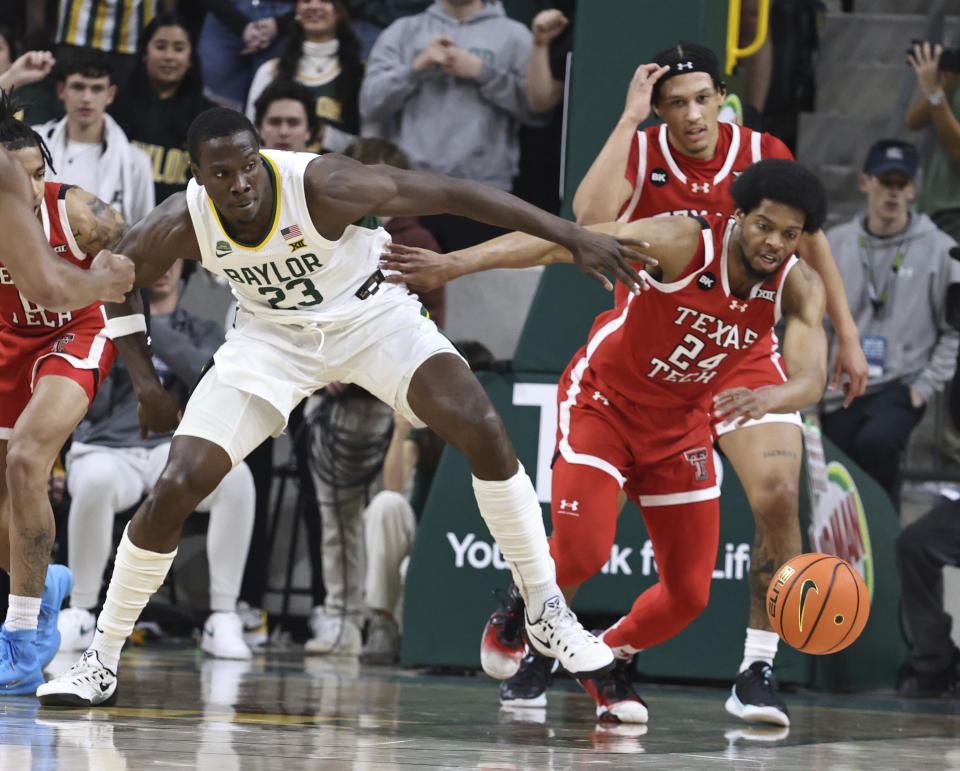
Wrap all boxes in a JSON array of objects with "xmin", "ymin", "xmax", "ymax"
[{"xmin": 0, "ymin": 90, "xmax": 132, "ymax": 694}]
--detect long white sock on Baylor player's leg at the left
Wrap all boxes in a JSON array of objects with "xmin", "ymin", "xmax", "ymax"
[{"xmin": 90, "ymin": 525, "xmax": 177, "ymax": 672}]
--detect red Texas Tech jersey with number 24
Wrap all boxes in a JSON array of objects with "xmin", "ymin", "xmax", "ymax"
[{"xmin": 584, "ymin": 216, "xmax": 797, "ymax": 407}]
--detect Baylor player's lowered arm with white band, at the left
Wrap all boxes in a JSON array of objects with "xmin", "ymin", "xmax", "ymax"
[{"xmin": 104, "ymin": 193, "xmax": 200, "ymax": 438}]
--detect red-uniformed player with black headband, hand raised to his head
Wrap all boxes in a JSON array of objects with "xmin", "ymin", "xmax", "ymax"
[{"xmin": 573, "ymin": 43, "xmax": 867, "ymax": 725}]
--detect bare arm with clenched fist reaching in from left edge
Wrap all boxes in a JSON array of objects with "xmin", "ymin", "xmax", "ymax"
[{"xmin": 0, "ymin": 150, "xmax": 133, "ymax": 311}]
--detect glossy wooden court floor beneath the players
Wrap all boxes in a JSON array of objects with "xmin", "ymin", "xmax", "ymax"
[{"xmin": 0, "ymin": 648, "xmax": 960, "ymax": 771}]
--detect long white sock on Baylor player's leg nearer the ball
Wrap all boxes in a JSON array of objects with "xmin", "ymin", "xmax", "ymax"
[{"xmin": 473, "ymin": 464, "xmax": 560, "ymax": 620}]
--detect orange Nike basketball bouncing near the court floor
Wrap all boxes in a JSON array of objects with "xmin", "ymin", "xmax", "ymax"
[{"xmin": 767, "ymin": 554, "xmax": 870, "ymax": 656}]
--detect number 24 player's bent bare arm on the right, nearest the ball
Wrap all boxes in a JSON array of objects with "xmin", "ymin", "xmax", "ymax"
[{"xmin": 713, "ymin": 262, "xmax": 827, "ymax": 423}]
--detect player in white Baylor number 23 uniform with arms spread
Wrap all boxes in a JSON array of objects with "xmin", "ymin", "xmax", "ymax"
[{"xmin": 37, "ymin": 108, "xmax": 641, "ymax": 706}]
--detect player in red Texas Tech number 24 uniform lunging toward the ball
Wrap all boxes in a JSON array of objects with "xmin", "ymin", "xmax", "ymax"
[{"xmin": 384, "ymin": 159, "xmax": 826, "ymax": 722}]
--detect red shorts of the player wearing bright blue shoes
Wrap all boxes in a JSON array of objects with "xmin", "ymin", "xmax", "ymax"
[{"xmin": 0, "ymin": 308, "xmax": 117, "ymax": 440}]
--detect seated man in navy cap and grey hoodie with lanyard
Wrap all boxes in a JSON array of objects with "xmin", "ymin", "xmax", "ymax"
[{"xmin": 821, "ymin": 139, "xmax": 960, "ymax": 503}]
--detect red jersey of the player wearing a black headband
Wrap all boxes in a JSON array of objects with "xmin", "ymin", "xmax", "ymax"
[{"xmin": 618, "ymin": 122, "xmax": 793, "ymax": 222}]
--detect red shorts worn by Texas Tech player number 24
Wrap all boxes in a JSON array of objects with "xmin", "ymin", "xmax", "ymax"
[{"xmin": 557, "ymin": 354, "xmax": 720, "ymax": 508}]
